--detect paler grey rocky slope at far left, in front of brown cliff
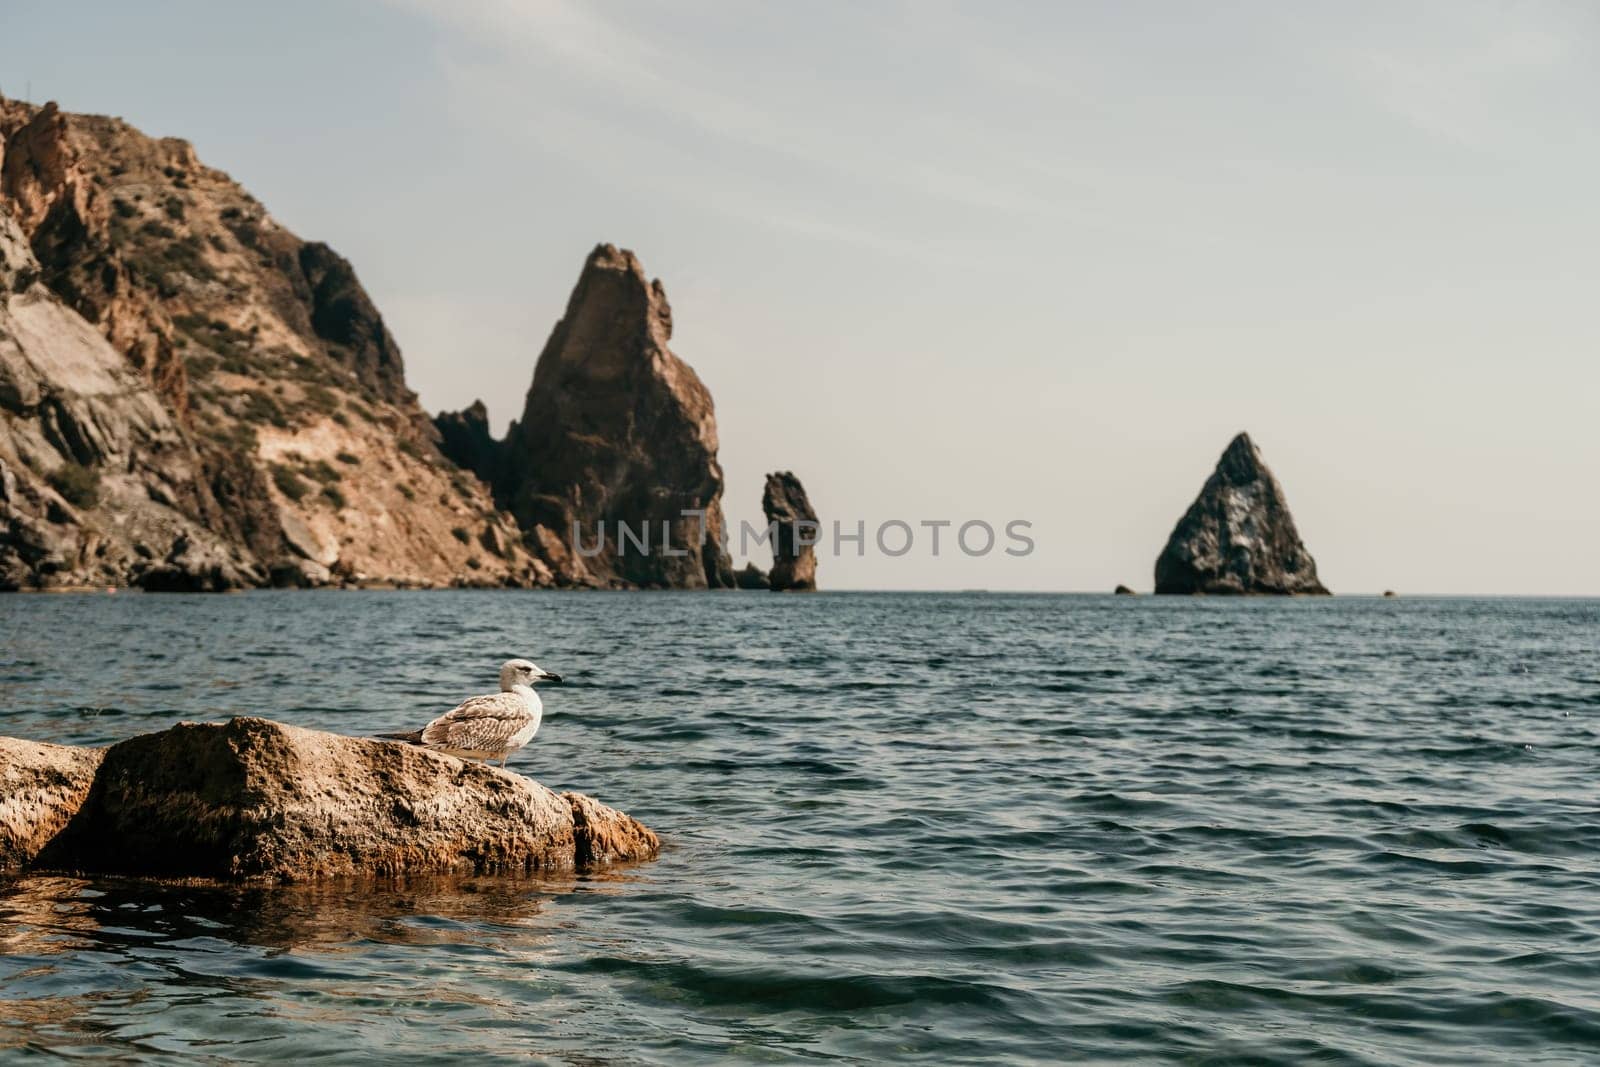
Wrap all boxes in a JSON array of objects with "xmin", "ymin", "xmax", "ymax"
[{"xmin": 0, "ymin": 203, "xmax": 266, "ymax": 590}]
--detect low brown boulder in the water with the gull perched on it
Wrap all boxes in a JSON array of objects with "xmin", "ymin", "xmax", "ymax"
[{"xmin": 38, "ymin": 718, "xmax": 659, "ymax": 881}]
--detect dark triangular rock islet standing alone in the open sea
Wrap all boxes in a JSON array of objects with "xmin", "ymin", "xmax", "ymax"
[{"xmin": 1155, "ymin": 434, "xmax": 1328, "ymax": 595}]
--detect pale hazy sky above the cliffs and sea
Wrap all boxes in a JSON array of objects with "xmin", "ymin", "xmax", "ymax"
[{"xmin": 0, "ymin": 0, "xmax": 1600, "ymax": 595}]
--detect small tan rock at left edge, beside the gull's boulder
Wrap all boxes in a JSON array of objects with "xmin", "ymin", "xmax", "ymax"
[{"xmin": 0, "ymin": 737, "xmax": 106, "ymax": 872}]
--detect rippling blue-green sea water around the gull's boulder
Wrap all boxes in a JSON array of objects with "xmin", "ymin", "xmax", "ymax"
[{"xmin": 0, "ymin": 592, "xmax": 1600, "ymax": 1064}]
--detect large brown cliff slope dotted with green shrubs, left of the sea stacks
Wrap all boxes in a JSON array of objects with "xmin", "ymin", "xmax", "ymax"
[{"xmin": 0, "ymin": 99, "xmax": 540, "ymax": 589}]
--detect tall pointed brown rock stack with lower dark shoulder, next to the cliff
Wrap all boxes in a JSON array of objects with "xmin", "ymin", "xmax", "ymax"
[{"xmin": 437, "ymin": 245, "xmax": 733, "ymax": 589}]
